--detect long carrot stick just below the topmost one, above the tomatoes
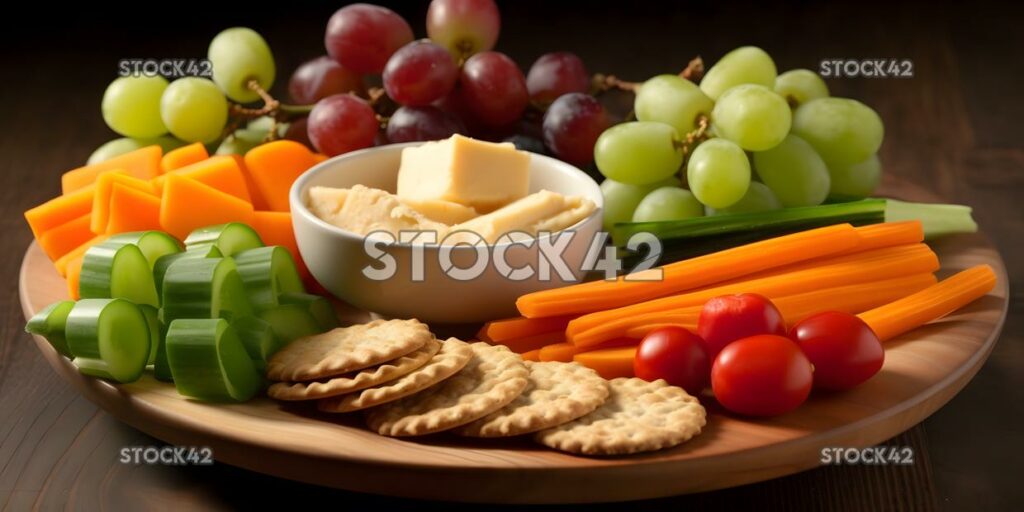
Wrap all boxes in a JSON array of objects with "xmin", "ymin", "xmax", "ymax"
[{"xmin": 565, "ymin": 244, "xmax": 939, "ymax": 340}]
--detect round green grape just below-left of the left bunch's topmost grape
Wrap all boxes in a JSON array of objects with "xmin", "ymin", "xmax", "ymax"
[{"xmin": 160, "ymin": 77, "xmax": 227, "ymax": 143}]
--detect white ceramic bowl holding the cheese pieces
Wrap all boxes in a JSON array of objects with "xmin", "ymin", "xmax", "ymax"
[{"xmin": 290, "ymin": 142, "xmax": 603, "ymax": 324}]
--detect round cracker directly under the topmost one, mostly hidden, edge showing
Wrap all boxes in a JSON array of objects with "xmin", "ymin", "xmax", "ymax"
[{"xmin": 266, "ymin": 340, "xmax": 441, "ymax": 400}]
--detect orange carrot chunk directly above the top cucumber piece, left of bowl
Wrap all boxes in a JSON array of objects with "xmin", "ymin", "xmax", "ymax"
[{"xmin": 160, "ymin": 173, "xmax": 253, "ymax": 240}]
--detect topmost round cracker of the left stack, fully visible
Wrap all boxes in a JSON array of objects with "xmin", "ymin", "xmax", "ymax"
[{"xmin": 266, "ymin": 319, "xmax": 434, "ymax": 382}]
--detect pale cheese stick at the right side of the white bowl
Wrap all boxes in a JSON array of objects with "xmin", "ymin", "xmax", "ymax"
[{"xmin": 444, "ymin": 190, "xmax": 595, "ymax": 244}]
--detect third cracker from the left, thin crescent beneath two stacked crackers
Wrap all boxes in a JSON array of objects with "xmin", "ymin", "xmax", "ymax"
[{"xmin": 316, "ymin": 338, "xmax": 473, "ymax": 413}]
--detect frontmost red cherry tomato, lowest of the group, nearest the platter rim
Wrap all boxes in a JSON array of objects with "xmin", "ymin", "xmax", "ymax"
[{"xmin": 711, "ymin": 335, "xmax": 813, "ymax": 416}]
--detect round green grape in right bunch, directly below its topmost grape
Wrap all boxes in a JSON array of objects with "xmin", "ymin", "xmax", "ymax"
[{"xmin": 711, "ymin": 84, "xmax": 793, "ymax": 152}]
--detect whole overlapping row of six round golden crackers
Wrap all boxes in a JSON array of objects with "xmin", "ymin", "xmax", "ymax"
[{"xmin": 267, "ymin": 319, "xmax": 706, "ymax": 455}]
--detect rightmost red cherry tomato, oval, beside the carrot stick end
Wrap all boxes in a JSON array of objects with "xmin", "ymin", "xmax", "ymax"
[{"xmin": 791, "ymin": 311, "xmax": 886, "ymax": 390}]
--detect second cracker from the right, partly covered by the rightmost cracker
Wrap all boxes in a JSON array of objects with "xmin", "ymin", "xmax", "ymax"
[{"xmin": 458, "ymin": 360, "xmax": 608, "ymax": 437}]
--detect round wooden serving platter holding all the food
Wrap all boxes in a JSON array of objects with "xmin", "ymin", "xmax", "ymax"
[{"xmin": 18, "ymin": 186, "xmax": 1008, "ymax": 503}]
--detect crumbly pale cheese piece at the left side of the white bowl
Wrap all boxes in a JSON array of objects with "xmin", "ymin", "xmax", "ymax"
[{"xmin": 308, "ymin": 185, "xmax": 449, "ymax": 240}]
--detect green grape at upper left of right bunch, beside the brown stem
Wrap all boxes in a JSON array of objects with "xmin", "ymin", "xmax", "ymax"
[{"xmin": 633, "ymin": 75, "xmax": 715, "ymax": 135}]
